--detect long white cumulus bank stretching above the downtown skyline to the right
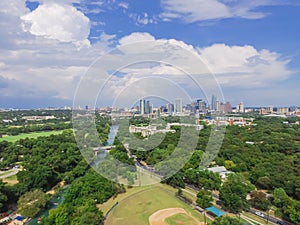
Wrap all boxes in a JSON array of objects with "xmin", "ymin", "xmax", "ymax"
[{"xmin": 95, "ymin": 33, "xmax": 292, "ymax": 107}]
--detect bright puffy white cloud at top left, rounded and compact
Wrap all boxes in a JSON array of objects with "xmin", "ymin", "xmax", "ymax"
[{"xmin": 21, "ymin": 3, "xmax": 90, "ymax": 44}]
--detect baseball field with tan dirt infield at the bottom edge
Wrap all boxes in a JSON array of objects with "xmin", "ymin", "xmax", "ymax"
[{"xmin": 99, "ymin": 184, "xmax": 203, "ymax": 225}]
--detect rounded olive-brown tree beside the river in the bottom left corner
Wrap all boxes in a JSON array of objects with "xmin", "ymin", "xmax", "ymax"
[{"xmin": 18, "ymin": 190, "xmax": 47, "ymax": 217}]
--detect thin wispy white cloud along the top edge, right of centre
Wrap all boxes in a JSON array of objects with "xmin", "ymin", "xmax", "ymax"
[{"xmin": 161, "ymin": 0, "xmax": 297, "ymax": 23}]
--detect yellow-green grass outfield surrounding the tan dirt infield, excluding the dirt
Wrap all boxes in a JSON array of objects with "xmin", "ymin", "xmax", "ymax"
[{"xmin": 99, "ymin": 184, "xmax": 203, "ymax": 225}]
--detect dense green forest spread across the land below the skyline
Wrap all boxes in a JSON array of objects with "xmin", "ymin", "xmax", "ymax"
[{"xmin": 0, "ymin": 115, "xmax": 300, "ymax": 224}]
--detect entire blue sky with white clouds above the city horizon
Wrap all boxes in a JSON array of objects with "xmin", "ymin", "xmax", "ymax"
[{"xmin": 0, "ymin": 0, "xmax": 300, "ymax": 108}]
